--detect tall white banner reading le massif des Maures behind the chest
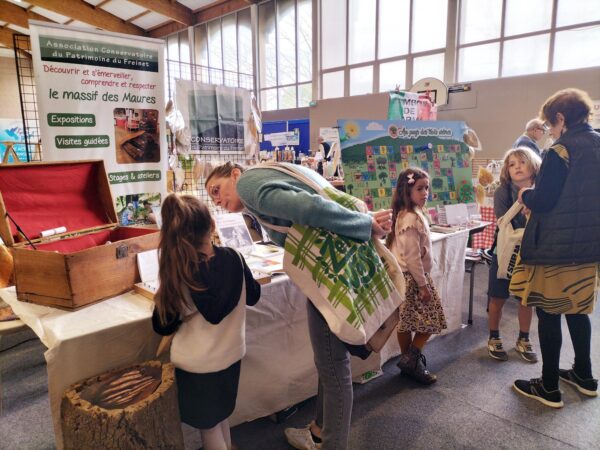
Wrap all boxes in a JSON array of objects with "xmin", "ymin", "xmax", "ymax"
[{"xmin": 29, "ymin": 21, "xmax": 168, "ymax": 225}]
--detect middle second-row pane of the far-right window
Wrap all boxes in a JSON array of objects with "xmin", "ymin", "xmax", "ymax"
[{"xmin": 502, "ymin": 34, "xmax": 550, "ymax": 77}]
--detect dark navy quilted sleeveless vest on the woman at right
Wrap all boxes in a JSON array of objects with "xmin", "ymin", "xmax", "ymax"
[{"xmin": 521, "ymin": 124, "xmax": 600, "ymax": 265}]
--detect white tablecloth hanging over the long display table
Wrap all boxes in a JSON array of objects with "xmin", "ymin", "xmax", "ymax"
[{"xmin": 0, "ymin": 231, "xmax": 468, "ymax": 448}]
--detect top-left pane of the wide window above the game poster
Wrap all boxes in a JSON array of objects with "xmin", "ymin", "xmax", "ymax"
[{"xmin": 321, "ymin": 0, "xmax": 346, "ymax": 69}]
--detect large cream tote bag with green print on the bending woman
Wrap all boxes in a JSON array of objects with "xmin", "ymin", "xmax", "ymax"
[{"xmin": 248, "ymin": 163, "xmax": 405, "ymax": 351}]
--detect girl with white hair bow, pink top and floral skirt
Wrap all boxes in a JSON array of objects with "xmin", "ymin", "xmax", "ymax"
[{"xmin": 387, "ymin": 168, "xmax": 447, "ymax": 385}]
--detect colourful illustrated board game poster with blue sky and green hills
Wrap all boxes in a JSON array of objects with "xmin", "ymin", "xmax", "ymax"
[{"xmin": 338, "ymin": 120, "xmax": 474, "ymax": 211}]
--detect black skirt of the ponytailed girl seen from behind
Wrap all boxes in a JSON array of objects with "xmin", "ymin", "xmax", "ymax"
[{"xmin": 175, "ymin": 361, "xmax": 241, "ymax": 430}]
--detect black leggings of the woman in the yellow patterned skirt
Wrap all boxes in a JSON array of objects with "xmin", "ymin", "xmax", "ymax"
[{"xmin": 535, "ymin": 308, "xmax": 592, "ymax": 391}]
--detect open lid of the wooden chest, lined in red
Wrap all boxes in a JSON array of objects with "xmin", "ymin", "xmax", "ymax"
[{"xmin": 0, "ymin": 160, "xmax": 117, "ymax": 246}]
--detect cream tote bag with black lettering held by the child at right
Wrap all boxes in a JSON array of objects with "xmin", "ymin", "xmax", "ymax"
[{"xmin": 496, "ymin": 202, "xmax": 525, "ymax": 280}]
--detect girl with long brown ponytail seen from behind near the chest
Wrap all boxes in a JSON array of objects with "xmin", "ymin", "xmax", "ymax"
[{"xmin": 152, "ymin": 194, "xmax": 260, "ymax": 450}]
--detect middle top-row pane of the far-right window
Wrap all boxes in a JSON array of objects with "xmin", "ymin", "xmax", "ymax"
[{"xmin": 504, "ymin": 0, "xmax": 552, "ymax": 36}]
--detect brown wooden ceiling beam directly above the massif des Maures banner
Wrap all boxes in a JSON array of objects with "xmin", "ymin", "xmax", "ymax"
[{"xmin": 27, "ymin": 0, "xmax": 146, "ymax": 36}]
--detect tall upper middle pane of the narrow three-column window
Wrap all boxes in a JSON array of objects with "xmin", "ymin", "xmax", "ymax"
[{"xmin": 276, "ymin": 0, "xmax": 296, "ymax": 84}]
